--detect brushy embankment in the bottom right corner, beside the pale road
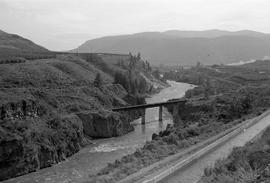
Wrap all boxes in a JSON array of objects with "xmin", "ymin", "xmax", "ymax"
[{"xmin": 198, "ymin": 117, "xmax": 270, "ymax": 183}]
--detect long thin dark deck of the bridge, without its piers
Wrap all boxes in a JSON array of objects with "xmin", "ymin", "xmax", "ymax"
[{"xmin": 112, "ymin": 99, "xmax": 186, "ymax": 111}]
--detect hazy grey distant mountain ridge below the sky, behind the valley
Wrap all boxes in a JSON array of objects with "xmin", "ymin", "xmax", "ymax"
[{"xmin": 73, "ymin": 30, "xmax": 270, "ymax": 65}]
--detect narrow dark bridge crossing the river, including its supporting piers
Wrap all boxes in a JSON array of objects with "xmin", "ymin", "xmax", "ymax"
[{"xmin": 112, "ymin": 99, "xmax": 187, "ymax": 124}]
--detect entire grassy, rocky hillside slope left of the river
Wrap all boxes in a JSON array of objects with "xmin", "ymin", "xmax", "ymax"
[{"xmin": 0, "ymin": 52, "xmax": 167, "ymax": 180}]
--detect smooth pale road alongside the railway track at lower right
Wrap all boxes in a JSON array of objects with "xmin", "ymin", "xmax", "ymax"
[{"xmin": 161, "ymin": 110, "xmax": 270, "ymax": 183}]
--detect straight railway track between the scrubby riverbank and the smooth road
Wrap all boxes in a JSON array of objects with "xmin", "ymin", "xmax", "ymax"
[{"xmin": 120, "ymin": 110, "xmax": 270, "ymax": 183}]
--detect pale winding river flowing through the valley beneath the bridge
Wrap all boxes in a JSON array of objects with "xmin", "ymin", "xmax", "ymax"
[{"xmin": 5, "ymin": 81, "xmax": 194, "ymax": 183}]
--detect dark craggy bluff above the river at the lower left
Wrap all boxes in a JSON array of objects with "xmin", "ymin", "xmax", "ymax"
[{"xmin": 0, "ymin": 115, "xmax": 83, "ymax": 180}]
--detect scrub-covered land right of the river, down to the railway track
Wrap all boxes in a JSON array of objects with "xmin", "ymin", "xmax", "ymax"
[{"xmin": 88, "ymin": 60, "xmax": 270, "ymax": 182}]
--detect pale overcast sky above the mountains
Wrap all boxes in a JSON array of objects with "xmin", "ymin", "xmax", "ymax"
[{"xmin": 0, "ymin": 0, "xmax": 270, "ymax": 51}]
